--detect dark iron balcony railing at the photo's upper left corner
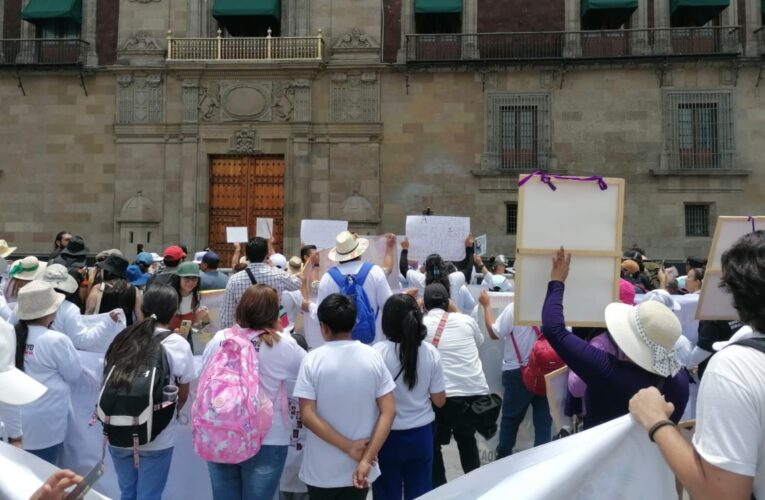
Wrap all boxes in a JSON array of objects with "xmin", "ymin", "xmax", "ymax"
[{"xmin": 0, "ymin": 38, "xmax": 88, "ymax": 66}]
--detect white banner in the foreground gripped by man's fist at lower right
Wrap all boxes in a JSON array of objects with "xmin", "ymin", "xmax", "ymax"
[{"xmin": 420, "ymin": 415, "xmax": 677, "ymax": 500}]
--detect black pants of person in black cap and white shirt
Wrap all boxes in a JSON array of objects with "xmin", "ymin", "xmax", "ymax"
[{"xmin": 433, "ymin": 396, "xmax": 482, "ymax": 488}]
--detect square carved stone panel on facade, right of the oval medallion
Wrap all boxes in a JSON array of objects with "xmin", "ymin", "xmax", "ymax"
[{"xmin": 330, "ymin": 73, "xmax": 380, "ymax": 122}]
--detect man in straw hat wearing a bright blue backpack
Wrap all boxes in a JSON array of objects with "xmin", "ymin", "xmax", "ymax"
[{"xmin": 316, "ymin": 231, "xmax": 392, "ymax": 343}]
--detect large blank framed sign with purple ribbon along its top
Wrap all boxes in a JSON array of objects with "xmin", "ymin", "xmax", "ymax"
[{"xmin": 514, "ymin": 175, "xmax": 624, "ymax": 326}]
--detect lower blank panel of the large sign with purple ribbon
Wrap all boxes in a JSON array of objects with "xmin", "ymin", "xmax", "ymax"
[{"xmin": 515, "ymin": 253, "xmax": 620, "ymax": 326}]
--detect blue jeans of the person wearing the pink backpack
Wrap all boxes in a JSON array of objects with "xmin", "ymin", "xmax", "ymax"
[{"xmin": 207, "ymin": 445, "xmax": 287, "ymax": 500}]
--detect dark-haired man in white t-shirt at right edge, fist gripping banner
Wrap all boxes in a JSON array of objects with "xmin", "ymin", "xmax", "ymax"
[{"xmin": 630, "ymin": 231, "xmax": 765, "ymax": 500}]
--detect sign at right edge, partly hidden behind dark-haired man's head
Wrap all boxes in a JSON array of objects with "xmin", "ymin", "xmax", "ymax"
[{"xmin": 696, "ymin": 216, "xmax": 765, "ymax": 320}]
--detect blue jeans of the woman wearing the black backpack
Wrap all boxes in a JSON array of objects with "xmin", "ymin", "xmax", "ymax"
[{"xmin": 109, "ymin": 446, "xmax": 173, "ymax": 500}]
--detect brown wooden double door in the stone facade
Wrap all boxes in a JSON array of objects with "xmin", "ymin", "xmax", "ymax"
[{"xmin": 208, "ymin": 156, "xmax": 284, "ymax": 267}]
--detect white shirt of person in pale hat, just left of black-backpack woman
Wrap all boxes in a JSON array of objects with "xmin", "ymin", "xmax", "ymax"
[{"xmin": 51, "ymin": 300, "xmax": 125, "ymax": 353}]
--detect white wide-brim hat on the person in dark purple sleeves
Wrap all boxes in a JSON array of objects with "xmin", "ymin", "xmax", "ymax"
[{"xmin": 606, "ymin": 301, "xmax": 682, "ymax": 377}]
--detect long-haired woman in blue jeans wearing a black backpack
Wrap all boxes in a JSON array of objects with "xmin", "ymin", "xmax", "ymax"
[{"xmin": 104, "ymin": 284, "xmax": 196, "ymax": 500}]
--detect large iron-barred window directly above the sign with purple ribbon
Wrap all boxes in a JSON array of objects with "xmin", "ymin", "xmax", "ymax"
[{"xmin": 484, "ymin": 92, "xmax": 550, "ymax": 171}]
